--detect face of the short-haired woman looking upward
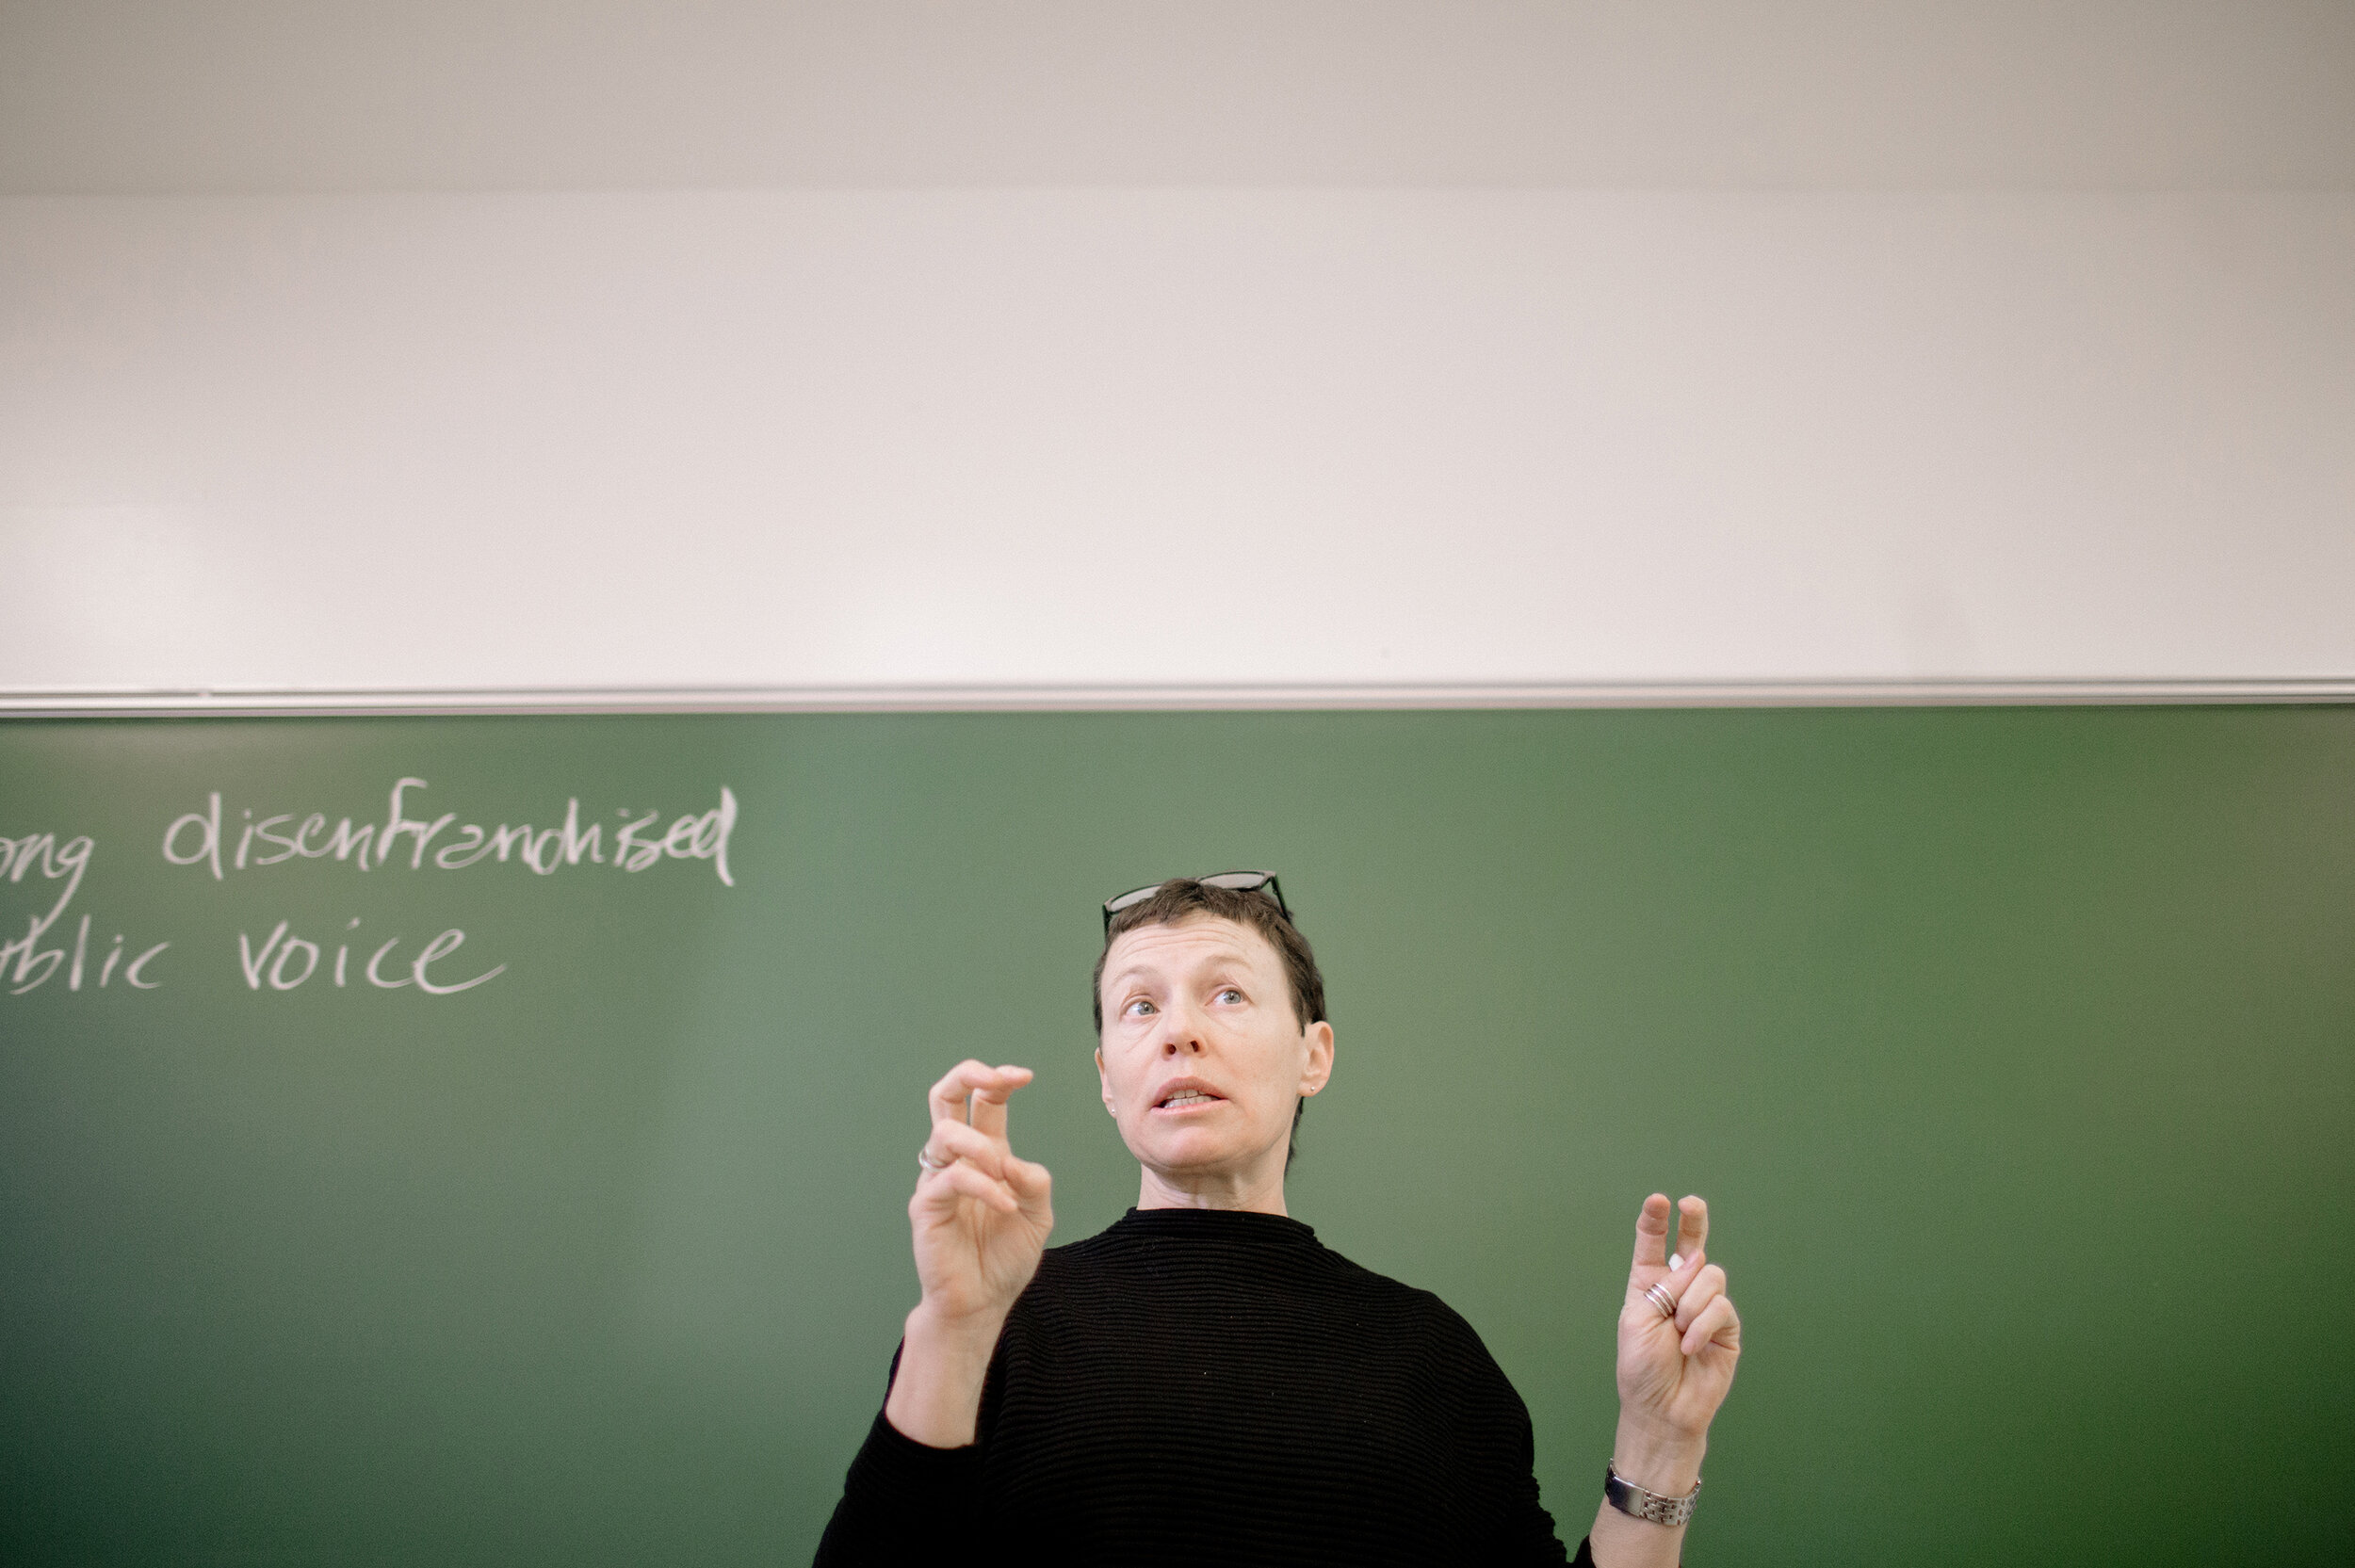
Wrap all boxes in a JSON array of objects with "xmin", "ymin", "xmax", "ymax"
[{"xmin": 1096, "ymin": 916, "xmax": 1333, "ymax": 1194}]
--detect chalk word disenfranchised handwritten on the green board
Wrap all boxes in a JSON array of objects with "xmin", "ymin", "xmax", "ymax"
[{"xmin": 163, "ymin": 780, "xmax": 738, "ymax": 888}]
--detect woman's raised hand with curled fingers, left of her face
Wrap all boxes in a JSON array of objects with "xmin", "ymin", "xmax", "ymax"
[{"xmin": 907, "ymin": 1062, "xmax": 1055, "ymax": 1340}]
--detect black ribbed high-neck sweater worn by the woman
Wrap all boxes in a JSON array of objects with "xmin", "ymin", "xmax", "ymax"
[{"xmin": 818, "ymin": 1208, "xmax": 1590, "ymax": 1568}]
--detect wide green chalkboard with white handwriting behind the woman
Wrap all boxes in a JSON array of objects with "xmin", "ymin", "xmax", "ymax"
[{"xmin": 0, "ymin": 706, "xmax": 2355, "ymax": 1568}]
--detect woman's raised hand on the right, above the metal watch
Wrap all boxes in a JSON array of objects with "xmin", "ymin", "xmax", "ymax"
[{"xmin": 1618, "ymin": 1191, "xmax": 1743, "ymax": 1441}]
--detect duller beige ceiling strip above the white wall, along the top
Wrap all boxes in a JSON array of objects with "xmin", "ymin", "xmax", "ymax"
[{"xmin": 0, "ymin": 0, "xmax": 2355, "ymax": 196}]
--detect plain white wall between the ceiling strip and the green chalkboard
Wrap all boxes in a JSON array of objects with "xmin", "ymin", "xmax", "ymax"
[{"xmin": 0, "ymin": 8, "xmax": 2355, "ymax": 692}]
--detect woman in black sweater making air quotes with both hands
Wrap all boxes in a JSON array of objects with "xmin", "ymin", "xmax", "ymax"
[{"xmin": 818, "ymin": 871, "xmax": 1741, "ymax": 1568}]
